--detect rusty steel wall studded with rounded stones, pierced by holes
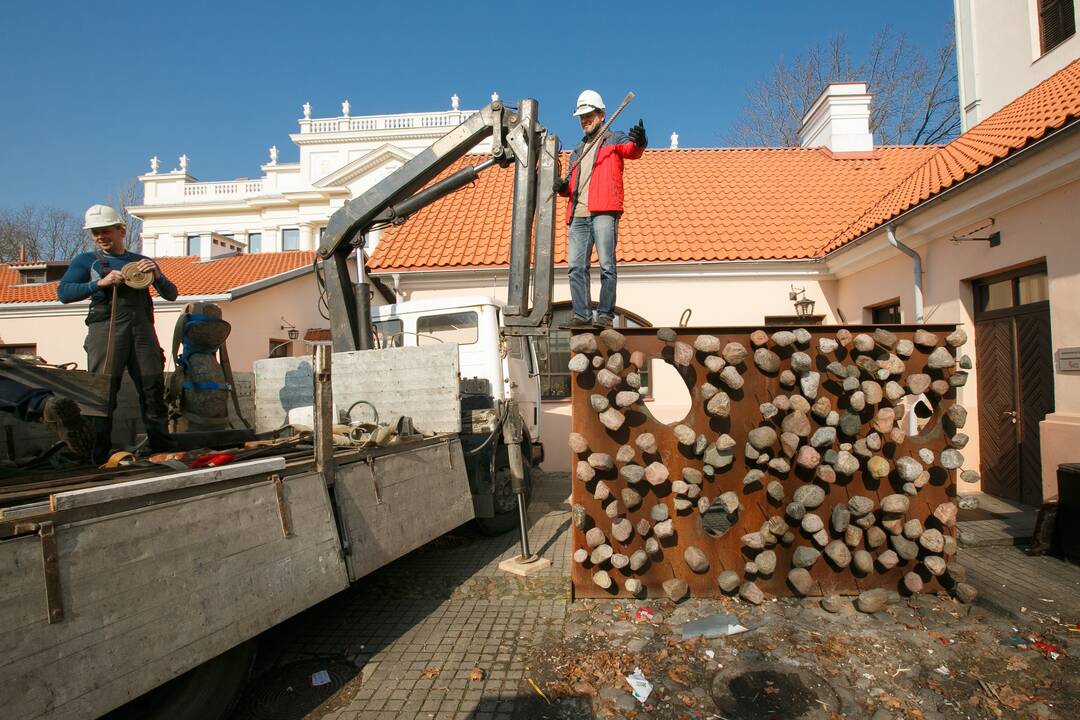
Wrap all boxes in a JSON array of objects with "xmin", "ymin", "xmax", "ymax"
[{"xmin": 569, "ymin": 325, "xmax": 977, "ymax": 601}]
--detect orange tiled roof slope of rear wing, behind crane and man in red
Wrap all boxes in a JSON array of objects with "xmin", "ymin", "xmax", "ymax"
[{"xmin": 368, "ymin": 147, "xmax": 935, "ymax": 271}]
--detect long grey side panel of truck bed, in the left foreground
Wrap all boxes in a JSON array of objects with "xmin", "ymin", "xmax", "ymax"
[{"xmin": 0, "ymin": 473, "xmax": 348, "ymax": 720}]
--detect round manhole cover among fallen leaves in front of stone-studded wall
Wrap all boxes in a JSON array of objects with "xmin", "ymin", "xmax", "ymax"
[{"xmin": 712, "ymin": 666, "xmax": 840, "ymax": 720}]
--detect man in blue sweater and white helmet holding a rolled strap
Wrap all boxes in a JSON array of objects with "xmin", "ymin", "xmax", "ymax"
[{"xmin": 56, "ymin": 205, "xmax": 176, "ymax": 463}]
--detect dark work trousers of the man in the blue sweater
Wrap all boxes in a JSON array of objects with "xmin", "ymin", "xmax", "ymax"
[{"xmin": 85, "ymin": 288, "xmax": 175, "ymax": 462}]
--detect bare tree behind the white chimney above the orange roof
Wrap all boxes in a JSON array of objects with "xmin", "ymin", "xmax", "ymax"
[{"xmin": 726, "ymin": 26, "xmax": 960, "ymax": 147}]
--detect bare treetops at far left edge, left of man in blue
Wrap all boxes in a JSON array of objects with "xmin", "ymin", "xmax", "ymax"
[{"xmin": 0, "ymin": 205, "xmax": 89, "ymax": 262}]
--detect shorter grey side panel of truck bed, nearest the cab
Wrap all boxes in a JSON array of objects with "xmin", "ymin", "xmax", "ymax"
[{"xmin": 336, "ymin": 438, "xmax": 474, "ymax": 581}]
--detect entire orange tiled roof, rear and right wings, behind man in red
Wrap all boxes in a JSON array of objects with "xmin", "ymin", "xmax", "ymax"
[{"xmin": 368, "ymin": 60, "xmax": 1080, "ymax": 272}]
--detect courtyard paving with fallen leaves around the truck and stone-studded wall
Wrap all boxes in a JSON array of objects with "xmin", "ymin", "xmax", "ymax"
[{"xmin": 235, "ymin": 474, "xmax": 1080, "ymax": 720}]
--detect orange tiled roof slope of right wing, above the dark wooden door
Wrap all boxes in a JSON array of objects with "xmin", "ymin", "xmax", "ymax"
[{"xmin": 819, "ymin": 59, "xmax": 1080, "ymax": 254}]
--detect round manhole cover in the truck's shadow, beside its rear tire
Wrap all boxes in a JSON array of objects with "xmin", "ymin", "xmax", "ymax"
[{"xmin": 235, "ymin": 658, "xmax": 359, "ymax": 720}]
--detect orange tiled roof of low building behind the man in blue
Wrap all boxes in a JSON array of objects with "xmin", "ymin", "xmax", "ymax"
[{"xmin": 0, "ymin": 252, "xmax": 315, "ymax": 303}]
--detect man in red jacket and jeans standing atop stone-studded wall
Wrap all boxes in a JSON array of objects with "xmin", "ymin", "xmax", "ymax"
[{"xmin": 556, "ymin": 90, "xmax": 649, "ymax": 327}]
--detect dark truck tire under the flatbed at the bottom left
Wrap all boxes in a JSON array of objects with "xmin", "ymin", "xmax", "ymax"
[{"xmin": 103, "ymin": 639, "xmax": 256, "ymax": 720}]
